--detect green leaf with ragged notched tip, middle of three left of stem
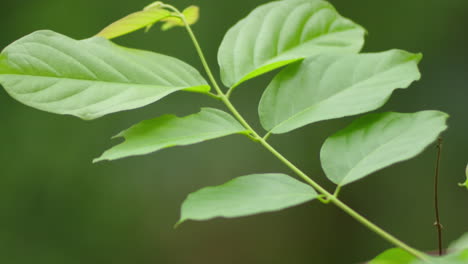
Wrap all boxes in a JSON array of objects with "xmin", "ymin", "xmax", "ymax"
[{"xmin": 94, "ymin": 108, "xmax": 247, "ymax": 162}]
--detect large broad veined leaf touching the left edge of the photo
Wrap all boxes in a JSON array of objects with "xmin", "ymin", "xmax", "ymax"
[{"xmin": 0, "ymin": 31, "xmax": 210, "ymax": 119}]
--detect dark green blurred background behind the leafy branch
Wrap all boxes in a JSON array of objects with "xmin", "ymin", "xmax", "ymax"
[{"xmin": 0, "ymin": 0, "xmax": 468, "ymax": 264}]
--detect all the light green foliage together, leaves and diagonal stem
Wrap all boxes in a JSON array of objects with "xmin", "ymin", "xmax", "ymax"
[{"xmin": 0, "ymin": 0, "xmax": 468, "ymax": 264}]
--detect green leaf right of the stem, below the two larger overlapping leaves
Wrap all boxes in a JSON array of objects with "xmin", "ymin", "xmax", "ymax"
[{"xmin": 320, "ymin": 111, "xmax": 448, "ymax": 186}]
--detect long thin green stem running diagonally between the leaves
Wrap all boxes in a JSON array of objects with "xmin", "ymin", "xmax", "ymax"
[{"xmin": 168, "ymin": 6, "xmax": 430, "ymax": 263}]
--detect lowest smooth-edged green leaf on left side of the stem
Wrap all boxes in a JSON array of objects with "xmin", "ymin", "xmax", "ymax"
[{"xmin": 178, "ymin": 174, "xmax": 317, "ymax": 227}]
